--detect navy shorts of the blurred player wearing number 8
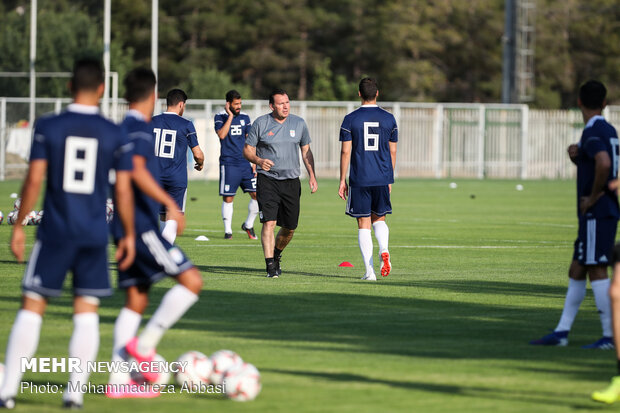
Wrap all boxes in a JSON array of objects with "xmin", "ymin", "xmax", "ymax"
[{"xmin": 22, "ymin": 240, "xmax": 113, "ymax": 297}]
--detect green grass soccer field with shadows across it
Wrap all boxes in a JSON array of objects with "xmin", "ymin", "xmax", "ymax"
[{"xmin": 0, "ymin": 180, "xmax": 615, "ymax": 413}]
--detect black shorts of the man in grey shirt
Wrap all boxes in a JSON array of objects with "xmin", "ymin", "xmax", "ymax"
[{"xmin": 256, "ymin": 174, "xmax": 301, "ymax": 229}]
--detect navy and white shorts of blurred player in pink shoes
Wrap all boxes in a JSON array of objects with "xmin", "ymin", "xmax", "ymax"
[{"xmin": 118, "ymin": 230, "xmax": 194, "ymax": 288}]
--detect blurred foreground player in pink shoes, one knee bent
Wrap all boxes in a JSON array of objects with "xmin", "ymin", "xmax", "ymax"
[{"xmin": 106, "ymin": 69, "xmax": 202, "ymax": 398}]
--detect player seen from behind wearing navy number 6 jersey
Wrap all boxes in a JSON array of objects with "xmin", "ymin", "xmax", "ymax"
[{"xmin": 338, "ymin": 78, "xmax": 398, "ymax": 281}]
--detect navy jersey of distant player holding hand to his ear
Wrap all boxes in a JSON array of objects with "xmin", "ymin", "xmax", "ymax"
[{"xmin": 214, "ymin": 110, "xmax": 252, "ymax": 165}]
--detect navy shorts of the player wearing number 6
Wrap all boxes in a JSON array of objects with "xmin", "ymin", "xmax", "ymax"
[{"xmin": 345, "ymin": 185, "xmax": 392, "ymax": 218}]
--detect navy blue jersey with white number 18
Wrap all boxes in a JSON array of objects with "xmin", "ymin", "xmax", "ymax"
[{"xmin": 151, "ymin": 112, "xmax": 198, "ymax": 186}]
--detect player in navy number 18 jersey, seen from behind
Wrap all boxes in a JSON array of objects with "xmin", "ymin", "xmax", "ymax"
[{"xmin": 151, "ymin": 89, "xmax": 205, "ymax": 244}]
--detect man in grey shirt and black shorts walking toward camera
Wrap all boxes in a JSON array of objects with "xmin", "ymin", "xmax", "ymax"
[{"xmin": 243, "ymin": 89, "xmax": 318, "ymax": 278}]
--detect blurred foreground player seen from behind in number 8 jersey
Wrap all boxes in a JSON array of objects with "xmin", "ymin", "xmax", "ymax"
[{"xmin": 0, "ymin": 59, "xmax": 135, "ymax": 408}]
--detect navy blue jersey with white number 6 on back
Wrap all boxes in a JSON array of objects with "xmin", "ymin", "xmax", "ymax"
[{"xmin": 340, "ymin": 105, "xmax": 398, "ymax": 186}]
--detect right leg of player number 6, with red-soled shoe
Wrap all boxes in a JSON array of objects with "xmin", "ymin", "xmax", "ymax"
[{"xmin": 370, "ymin": 185, "xmax": 392, "ymax": 277}]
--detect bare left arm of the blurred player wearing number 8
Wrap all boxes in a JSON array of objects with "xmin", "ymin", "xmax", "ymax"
[{"xmin": 11, "ymin": 159, "xmax": 47, "ymax": 261}]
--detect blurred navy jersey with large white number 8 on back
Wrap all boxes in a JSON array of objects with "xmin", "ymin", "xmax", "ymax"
[{"xmin": 30, "ymin": 104, "xmax": 132, "ymax": 247}]
